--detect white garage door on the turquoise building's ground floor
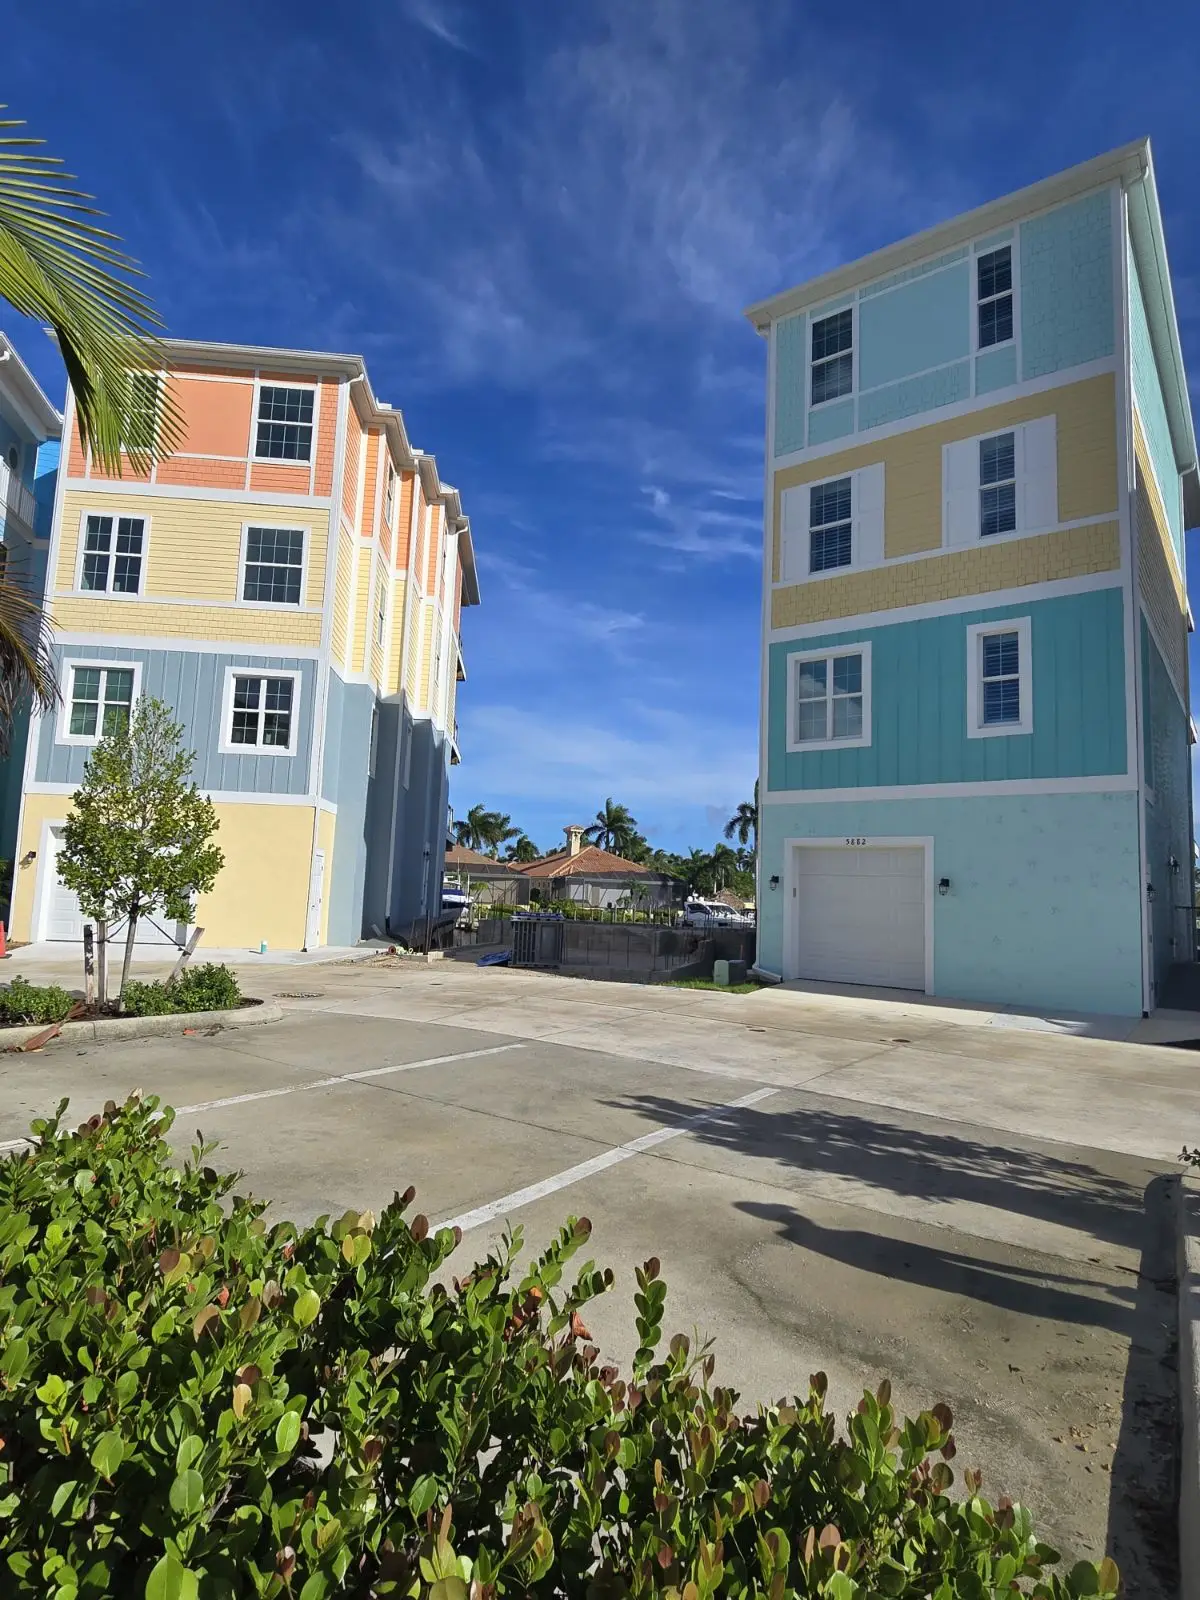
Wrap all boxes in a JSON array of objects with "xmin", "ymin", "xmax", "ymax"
[{"xmin": 795, "ymin": 845, "xmax": 925, "ymax": 990}]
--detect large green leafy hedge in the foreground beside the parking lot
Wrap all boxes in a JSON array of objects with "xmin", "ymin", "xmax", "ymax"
[{"xmin": 0, "ymin": 1098, "xmax": 1117, "ymax": 1600}]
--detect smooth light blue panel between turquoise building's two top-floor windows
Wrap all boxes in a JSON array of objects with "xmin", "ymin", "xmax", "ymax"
[{"xmin": 858, "ymin": 261, "xmax": 971, "ymax": 389}]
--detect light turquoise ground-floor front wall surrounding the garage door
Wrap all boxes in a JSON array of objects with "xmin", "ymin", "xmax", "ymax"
[{"xmin": 758, "ymin": 790, "xmax": 1142, "ymax": 1016}]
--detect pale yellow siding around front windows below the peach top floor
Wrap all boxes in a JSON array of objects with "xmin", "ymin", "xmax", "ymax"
[{"xmin": 56, "ymin": 490, "xmax": 330, "ymax": 605}]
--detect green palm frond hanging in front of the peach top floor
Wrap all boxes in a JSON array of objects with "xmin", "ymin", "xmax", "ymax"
[{"xmin": 0, "ymin": 106, "xmax": 182, "ymax": 474}]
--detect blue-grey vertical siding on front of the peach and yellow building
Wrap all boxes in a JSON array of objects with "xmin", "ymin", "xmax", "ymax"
[{"xmin": 35, "ymin": 645, "xmax": 315, "ymax": 795}]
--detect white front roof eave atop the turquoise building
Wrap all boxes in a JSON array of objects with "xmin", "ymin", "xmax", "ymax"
[{"xmin": 744, "ymin": 139, "xmax": 1150, "ymax": 334}]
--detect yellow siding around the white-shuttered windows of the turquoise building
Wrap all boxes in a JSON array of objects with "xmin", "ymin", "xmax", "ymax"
[{"xmin": 771, "ymin": 373, "xmax": 1117, "ymax": 587}]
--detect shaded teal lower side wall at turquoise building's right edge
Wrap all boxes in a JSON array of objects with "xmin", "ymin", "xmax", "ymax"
[{"xmin": 1142, "ymin": 618, "xmax": 1192, "ymax": 989}]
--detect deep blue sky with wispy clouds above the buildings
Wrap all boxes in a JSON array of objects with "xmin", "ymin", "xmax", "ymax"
[{"xmin": 0, "ymin": 0, "xmax": 1200, "ymax": 850}]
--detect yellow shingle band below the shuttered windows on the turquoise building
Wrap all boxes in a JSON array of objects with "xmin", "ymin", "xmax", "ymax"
[{"xmin": 771, "ymin": 522, "xmax": 1122, "ymax": 627}]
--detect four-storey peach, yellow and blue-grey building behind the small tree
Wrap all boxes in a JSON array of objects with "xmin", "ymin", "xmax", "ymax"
[{"xmin": 11, "ymin": 332, "xmax": 478, "ymax": 949}]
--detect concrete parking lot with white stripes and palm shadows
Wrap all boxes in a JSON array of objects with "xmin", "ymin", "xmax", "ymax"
[{"xmin": 0, "ymin": 963, "xmax": 1200, "ymax": 1595}]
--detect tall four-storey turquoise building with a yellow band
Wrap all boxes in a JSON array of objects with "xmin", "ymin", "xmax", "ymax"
[{"xmin": 747, "ymin": 141, "xmax": 1200, "ymax": 1016}]
